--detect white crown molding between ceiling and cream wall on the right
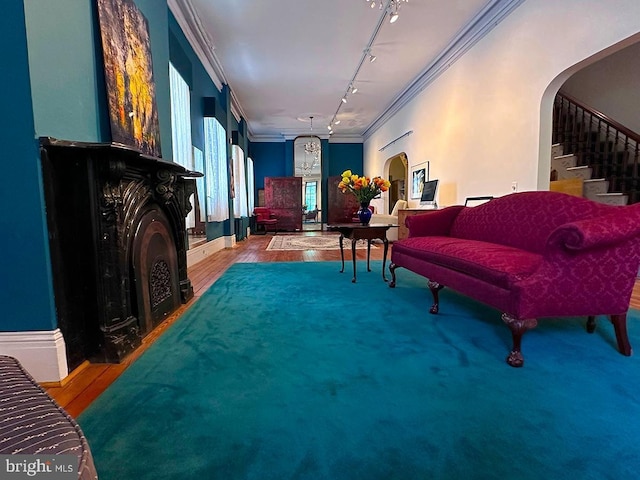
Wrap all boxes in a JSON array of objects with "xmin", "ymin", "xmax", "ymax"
[{"xmin": 362, "ymin": 0, "xmax": 525, "ymax": 139}]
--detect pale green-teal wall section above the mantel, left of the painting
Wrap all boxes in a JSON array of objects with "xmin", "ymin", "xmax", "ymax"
[{"xmin": 24, "ymin": 0, "xmax": 104, "ymax": 142}]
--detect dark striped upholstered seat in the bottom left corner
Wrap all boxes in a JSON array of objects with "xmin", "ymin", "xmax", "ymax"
[{"xmin": 0, "ymin": 355, "xmax": 98, "ymax": 480}]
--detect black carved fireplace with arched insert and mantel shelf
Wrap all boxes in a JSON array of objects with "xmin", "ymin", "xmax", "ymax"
[{"xmin": 40, "ymin": 137, "xmax": 201, "ymax": 369}]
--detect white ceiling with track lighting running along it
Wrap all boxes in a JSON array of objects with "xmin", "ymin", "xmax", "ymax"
[{"xmin": 169, "ymin": 0, "xmax": 524, "ymax": 140}]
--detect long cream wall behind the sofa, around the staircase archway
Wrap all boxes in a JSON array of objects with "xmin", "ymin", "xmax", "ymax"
[{"xmin": 364, "ymin": 0, "xmax": 640, "ymax": 206}]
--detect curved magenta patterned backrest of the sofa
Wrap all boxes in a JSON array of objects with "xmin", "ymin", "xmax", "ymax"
[{"xmin": 450, "ymin": 191, "xmax": 624, "ymax": 253}]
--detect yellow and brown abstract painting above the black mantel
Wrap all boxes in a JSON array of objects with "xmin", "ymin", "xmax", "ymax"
[{"xmin": 97, "ymin": 0, "xmax": 161, "ymax": 157}]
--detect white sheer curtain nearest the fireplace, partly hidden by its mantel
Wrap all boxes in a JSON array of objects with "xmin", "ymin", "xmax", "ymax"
[{"xmin": 169, "ymin": 63, "xmax": 196, "ymax": 228}]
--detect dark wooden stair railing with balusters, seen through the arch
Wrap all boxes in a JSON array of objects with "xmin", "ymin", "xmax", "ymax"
[{"xmin": 552, "ymin": 91, "xmax": 640, "ymax": 204}]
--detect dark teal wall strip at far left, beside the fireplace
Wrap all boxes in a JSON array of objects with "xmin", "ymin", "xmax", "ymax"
[{"xmin": 0, "ymin": 1, "xmax": 56, "ymax": 331}]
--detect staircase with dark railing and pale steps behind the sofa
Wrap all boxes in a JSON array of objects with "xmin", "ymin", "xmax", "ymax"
[{"xmin": 551, "ymin": 92, "xmax": 640, "ymax": 205}]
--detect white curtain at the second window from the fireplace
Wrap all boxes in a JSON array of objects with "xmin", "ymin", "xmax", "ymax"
[{"xmin": 204, "ymin": 117, "xmax": 229, "ymax": 222}]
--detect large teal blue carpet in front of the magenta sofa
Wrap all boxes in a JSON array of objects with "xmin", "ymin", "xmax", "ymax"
[{"xmin": 79, "ymin": 262, "xmax": 640, "ymax": 480}]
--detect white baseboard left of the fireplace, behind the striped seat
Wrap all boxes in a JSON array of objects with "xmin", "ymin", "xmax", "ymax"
[{"xmin": 0, "ymin": 328, "xmax": 69, "ymax": 382}]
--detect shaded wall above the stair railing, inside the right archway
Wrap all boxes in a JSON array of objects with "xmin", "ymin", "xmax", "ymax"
[{"xmin": 562, "ymin": 43, "xmax": 640, "ymax": 132}]
